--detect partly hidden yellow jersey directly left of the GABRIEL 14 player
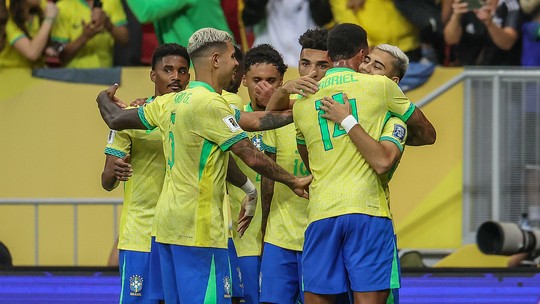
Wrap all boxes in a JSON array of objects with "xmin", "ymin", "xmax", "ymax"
[{"xmin": 264, "ymin": 124, "xmax": 309, "ymax": 251}]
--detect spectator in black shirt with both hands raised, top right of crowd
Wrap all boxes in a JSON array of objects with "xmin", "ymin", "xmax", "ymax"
[{"xmin": 444, "ymin": 0, "xmax": 521, "ymax": 66}]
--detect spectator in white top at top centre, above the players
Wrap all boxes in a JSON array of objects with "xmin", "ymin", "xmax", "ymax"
[{"xmin": 242, "ymin": 0, "xmax": 316, "ymax": 66}]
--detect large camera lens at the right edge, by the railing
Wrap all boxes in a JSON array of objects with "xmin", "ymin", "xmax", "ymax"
[{"xmin": 476, "ymin": 221, "xmax": 540, "ymax": 256}]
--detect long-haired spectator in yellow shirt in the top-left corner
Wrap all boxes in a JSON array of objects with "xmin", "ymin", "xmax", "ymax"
[{"xmin": 0, "ymin": 0, "xmax": 58, "ymax": 68}]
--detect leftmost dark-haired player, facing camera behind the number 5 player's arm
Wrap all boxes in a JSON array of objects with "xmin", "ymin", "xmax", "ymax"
[{"xmin": 101, "ymin": 44, "xmax": 190, "ymax": 303}]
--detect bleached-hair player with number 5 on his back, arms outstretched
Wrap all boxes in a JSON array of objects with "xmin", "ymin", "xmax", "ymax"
[{"xmin": 97, "ymin": 28, "xmax": 311, "ymax": 303}]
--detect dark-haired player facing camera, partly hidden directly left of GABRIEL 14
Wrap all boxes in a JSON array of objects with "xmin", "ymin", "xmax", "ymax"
[{"xmin": 261, "ymin": 29, "xmax": 331, "ymax": 303}]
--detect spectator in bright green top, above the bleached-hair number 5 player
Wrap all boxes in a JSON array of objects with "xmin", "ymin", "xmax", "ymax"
[{"xmin": 127, "ymin": 0, "xmax": 230, "ymax": 45}]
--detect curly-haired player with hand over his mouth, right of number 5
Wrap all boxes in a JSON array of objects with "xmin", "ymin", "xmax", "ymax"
[{"xmin": 228, "ymin": 44, "xmax": 288, "ymax": 303}]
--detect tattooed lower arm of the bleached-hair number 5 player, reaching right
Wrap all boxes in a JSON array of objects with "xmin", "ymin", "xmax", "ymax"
[{"xmin": 230, "ymin": 138, "xmax": 313, "ymax": 198}]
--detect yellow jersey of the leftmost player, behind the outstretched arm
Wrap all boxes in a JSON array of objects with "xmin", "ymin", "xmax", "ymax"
[{"xmin": 105, "ymin": 100, "xmax": 165, "ymax": 252}]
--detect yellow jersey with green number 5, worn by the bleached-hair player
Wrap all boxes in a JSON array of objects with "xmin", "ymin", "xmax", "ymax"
[{"xmin": 139, "ymin": 81, "xmax": 247, "ymax": 248}]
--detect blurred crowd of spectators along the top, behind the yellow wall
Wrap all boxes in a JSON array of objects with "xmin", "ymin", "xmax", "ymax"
[{"xmin": 0, "ymin": 0, "xmax": 540, "ymax": 68}]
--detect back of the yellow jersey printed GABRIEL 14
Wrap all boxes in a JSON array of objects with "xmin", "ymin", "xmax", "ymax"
[{"xmin": 293, "ymin": 68, "xmax": 396, "ymax": 222}]
